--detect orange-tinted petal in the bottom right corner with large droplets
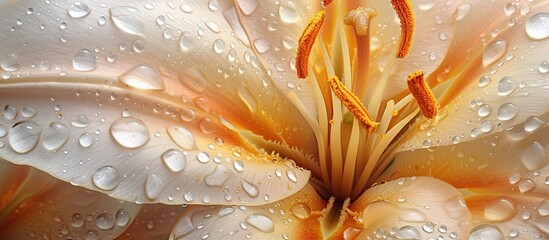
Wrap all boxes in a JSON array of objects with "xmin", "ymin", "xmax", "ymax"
[{"xmin": 465, "ymin": 195, "xmax": 549, "ymax": 239}]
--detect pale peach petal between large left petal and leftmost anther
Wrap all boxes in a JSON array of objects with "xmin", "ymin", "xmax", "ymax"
[{"xmin": 235, "ymin": 0, "xmax": 320, "ymax": 118}]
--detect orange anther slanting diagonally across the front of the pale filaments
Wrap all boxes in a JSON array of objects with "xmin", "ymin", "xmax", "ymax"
[{"xmin": 328, "ymin": 76, "xmax": 379, "ymax": 133}]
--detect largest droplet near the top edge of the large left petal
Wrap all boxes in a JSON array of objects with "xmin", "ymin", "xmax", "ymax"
[{"xmin": 110, "ymin": 6, "xmax": 145, "ymax": 35}]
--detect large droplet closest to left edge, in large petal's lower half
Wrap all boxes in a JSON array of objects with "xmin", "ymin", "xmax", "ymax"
[{"xmin": 8, "ymin": 122, "xmax": 42, "ymax": 153}]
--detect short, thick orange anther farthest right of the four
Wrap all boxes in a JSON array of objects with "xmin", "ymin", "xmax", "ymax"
[{"xmin": 408, "ymin": 71, "xmax": 438, "ymax": 119}]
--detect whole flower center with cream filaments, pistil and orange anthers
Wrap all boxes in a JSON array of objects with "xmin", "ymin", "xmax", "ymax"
[{"xmin": 290, "ymin": 0, "xmax": 437, "ymax": 202}]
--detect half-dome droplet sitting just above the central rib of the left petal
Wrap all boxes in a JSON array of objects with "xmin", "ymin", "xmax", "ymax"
[{"xmin": 118, "ymin": 64, "xmax": 165, "ymax": 90}]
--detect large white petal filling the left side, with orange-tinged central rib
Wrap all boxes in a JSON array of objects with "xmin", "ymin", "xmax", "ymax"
[{"xmin": 0, "ymin": 1, "xmax": 308, "ymax": 204}]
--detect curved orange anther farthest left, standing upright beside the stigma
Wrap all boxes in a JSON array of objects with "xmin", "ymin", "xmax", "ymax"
[{"xmin": 295, "ymin": 10, "xmax": 326, "ymax": 78}]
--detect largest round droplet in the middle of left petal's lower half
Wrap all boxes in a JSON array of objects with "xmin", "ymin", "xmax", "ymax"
[{"xmin": 109, "ymin": 117, "xmax": 150, "ymax": 148}]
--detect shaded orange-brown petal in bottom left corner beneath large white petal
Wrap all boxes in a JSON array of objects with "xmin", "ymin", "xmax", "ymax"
[{"xmin": 0, "ymin": 162, "xmax": 140, "ymax": 239}]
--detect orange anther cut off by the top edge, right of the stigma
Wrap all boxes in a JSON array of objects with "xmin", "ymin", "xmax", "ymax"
[{"xmin": 391, "ymin": 0, "xmax": 415, "ymax": 58}]
